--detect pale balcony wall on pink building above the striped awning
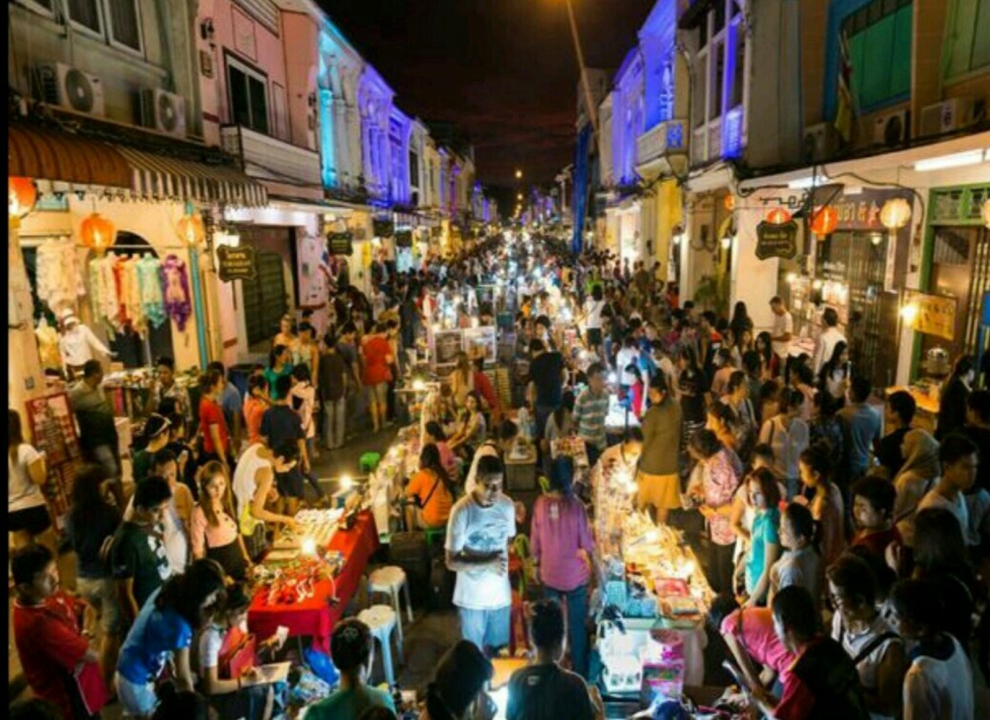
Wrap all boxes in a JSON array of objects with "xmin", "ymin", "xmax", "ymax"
[{"xmin": 220, "ymin": 125, "xmax": 323, "ymax": 187}]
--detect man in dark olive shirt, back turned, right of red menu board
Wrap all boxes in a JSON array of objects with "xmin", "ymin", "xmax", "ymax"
[{"xmin": 69, "ymin": 360, "xmax": 124, "ymax": 508}]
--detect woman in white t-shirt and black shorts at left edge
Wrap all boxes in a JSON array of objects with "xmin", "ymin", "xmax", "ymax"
[{"xmin": 7, "ymin": 410, "xmax": 52, "ymax": 548}]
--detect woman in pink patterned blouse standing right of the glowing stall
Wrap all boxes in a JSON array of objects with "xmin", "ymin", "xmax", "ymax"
[{"xmin": 688, "ymin": 429, "xmax": 743, "ymax": 593}]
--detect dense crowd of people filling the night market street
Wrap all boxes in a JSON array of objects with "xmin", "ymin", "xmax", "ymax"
[{"xmin": 9, "ymin": 236, "xmax": 990, "ymax": 720}]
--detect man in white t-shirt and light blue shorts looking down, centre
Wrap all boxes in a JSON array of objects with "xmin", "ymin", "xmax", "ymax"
[{"xmin": 446, "ymin": 457, "xmax": 516, "ymax": 651}]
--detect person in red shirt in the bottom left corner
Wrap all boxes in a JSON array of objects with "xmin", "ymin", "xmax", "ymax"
[{"xmin": 10, "ymin": 544, "xmax": 107, "ymax": 720}]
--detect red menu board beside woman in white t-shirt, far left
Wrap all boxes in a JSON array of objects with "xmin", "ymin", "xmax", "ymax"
[{"xmin": 25, "ymin": 393, "xmax": 82, "ymax": 530}]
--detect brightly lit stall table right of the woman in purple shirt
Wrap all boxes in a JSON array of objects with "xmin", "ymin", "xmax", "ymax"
[{"xmin": 591, "ymin": 456, "xmax": 714, "ymax": 697}]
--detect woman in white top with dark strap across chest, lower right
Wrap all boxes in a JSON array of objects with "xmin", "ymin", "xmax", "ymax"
[{"xmin": 826, "ymin": 553, "xmax": 907, "ymax": 720}]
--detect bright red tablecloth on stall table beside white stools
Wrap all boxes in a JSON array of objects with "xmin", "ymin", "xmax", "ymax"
[{"xmin": 248, "ymin": 511, "xmax": 378, "ymax": 653}]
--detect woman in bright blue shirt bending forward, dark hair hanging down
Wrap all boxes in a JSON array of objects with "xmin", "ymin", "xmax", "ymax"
[{"xmin": 115, "ymin": 558, "xmax": 224, "ymax": 718}]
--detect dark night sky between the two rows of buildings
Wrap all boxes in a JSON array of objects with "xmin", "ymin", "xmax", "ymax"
[{"xmin": 320, "ymin": 0, "xmax": 656, "ymax": 191}]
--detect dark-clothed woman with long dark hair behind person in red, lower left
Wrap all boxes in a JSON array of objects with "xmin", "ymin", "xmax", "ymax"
[{"xmin": 65, "ymin": 464, "xmax": 123, "ymax": 687}]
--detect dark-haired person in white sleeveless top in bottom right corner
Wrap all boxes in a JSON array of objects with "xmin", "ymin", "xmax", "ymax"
[{"xmin": 887, "ymin": 580, "xmax": 976, "ymax": 720}]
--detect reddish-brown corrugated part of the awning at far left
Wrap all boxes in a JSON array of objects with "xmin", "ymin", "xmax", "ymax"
[{"xmin": 7, "ymin": 125, "xmax": 131, "ymax": 189}]
